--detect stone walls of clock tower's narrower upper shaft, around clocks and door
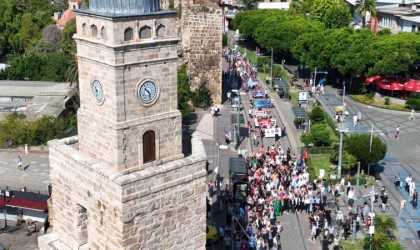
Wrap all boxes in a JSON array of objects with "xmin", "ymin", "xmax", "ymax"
[{"xmin": 75, "ymin": 12, "xmax": 182, "ymax": 173}]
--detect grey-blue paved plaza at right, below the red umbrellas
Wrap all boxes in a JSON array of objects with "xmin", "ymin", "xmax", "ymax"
[{"xmin": 320, "ymin": 85, "xmax": 420, "ymax": 249}]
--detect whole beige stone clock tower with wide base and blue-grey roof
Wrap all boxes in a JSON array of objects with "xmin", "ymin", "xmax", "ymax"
[{"xmin": 39, "ymin": 0, "xmax": 206, "ymax": 250}]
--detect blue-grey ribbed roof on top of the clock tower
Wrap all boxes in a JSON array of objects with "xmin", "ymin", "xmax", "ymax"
[{"xmin": 89, "ymin": 0, "xmax": 159, "ymax": 16}]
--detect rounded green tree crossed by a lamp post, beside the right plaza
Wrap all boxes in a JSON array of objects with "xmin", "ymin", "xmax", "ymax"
[{"xmin": 345, "ymin": 133, "xmax": 387, "ymax": 162}]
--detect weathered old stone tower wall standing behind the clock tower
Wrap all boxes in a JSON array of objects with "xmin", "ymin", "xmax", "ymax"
[{"xmin": 180, "ymin": 0, "xmax": 223, "ymax": 104}]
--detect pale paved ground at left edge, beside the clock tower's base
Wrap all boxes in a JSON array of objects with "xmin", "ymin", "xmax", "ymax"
[{"xmin": 0, "ymin": 150, "xmax": 50, "ymax": 194}]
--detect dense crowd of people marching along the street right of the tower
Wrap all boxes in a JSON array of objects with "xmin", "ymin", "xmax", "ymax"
[{"xmin": 213, "ymin": 47, "xmax": 417, "ymax": 250}]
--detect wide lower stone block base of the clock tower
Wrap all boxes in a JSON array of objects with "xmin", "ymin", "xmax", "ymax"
[{"xmin": 40, "ymin": 132, "xmax": 206, "ymax": 250}]
